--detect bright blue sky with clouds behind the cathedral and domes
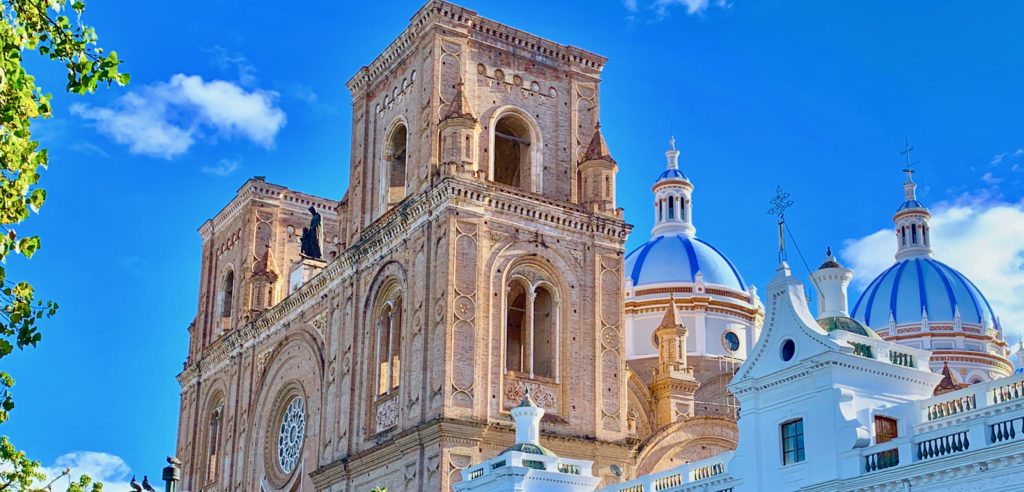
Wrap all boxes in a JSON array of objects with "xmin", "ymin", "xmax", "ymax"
[{"xmin": 8, "ymin": 0, "xmax": 1024, "ymax": 481}]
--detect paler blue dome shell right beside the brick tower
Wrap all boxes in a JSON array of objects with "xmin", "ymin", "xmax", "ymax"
[{"xmin": 626, "ymin": 235, "xmax": 746, "ymax": 291}]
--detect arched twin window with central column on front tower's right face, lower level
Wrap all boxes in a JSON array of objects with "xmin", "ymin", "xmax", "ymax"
[{"xmin": 505, "ymin": 277, "xmax": 559, "ymax": 379}]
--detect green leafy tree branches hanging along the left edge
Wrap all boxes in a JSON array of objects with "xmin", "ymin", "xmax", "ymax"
[{"xmin": 0, "ymin": 0, "xmax": 129, "ymax": 492}]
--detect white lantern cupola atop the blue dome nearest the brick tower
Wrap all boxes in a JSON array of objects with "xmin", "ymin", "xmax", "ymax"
[{"xmin": 650, "ymin": 137, "xmax": 696, "ymax": 237}]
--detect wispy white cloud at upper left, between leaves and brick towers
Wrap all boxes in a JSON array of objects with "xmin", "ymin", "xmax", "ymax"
[{"xmin": 71, "ymin": 74, "xmax": 286, "ymax": 159}]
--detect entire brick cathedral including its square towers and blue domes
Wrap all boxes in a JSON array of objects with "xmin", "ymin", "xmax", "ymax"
[{"xmin": 177, "ymin": 0, "xmax": 1013, "ymax": 492}]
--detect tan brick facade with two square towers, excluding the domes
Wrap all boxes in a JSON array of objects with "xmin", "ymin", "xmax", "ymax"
[{"xmin": 178, "ymin": 2, "xmax": 675, "ymax": 491}]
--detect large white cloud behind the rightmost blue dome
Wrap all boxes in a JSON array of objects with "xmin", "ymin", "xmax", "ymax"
[{"xmin": 841, "ymin": 194, "xmax": 1024, "ymax": 339}]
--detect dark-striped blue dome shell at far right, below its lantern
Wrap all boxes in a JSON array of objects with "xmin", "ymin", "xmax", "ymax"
[{"xmin": 852, "ymin": 258, "xmax": 997, "ymax": 329}]
